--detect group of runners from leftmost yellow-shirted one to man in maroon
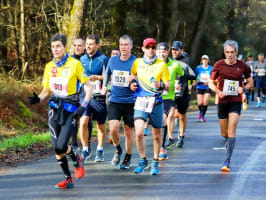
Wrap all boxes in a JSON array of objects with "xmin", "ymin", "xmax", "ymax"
[{"xmin": 30, "ymin": 34, "xmax": 253, "ymax": 189}]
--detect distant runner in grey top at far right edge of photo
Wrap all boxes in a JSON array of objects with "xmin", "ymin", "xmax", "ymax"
[{"xmin": 254, "ymin": 53, "xmax": 266, "ymax": 108}]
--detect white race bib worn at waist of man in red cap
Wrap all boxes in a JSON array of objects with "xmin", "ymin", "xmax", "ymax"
[{"xmin": 134, "ymin": 97, "xmax": 155, "ymax": 113}]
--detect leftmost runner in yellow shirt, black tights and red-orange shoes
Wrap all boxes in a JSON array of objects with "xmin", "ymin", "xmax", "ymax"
[{"xmin": 30, "ymin": 34, "xmax": 92, "ymax": 189}]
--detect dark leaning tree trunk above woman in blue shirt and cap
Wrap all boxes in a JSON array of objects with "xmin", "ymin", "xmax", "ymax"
[{"xmin": 190, "ymin": 0, "xmax": 211, "ymax": 66}]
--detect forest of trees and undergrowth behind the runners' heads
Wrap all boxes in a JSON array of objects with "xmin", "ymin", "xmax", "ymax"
[{"xmin": 0, "ymin": 0, "xmax": 266, "ymax": 80}]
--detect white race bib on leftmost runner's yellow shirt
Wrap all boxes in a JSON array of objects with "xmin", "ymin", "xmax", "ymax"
[{"xmin": 49, "ymin": 77, "xmax": 69, "ymax": 97}]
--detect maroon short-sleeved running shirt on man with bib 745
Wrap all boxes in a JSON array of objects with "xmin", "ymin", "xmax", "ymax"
[{"xmin": 210, "ymin": 59, "xmax": 250, "ymax": 103}]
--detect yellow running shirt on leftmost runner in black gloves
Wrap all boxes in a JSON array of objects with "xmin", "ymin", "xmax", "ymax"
[{"xmin": 42, "ymin": 57, "xmax": 88, "ymax": 97}]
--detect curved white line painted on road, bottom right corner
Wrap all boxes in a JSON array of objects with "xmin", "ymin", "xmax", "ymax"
[{"xmin": 227, "ymin": 141, "xmax": 266, "ymax": 200}]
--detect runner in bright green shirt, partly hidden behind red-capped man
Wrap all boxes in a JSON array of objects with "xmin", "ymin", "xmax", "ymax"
[{"xmin": 156, "ymin": 42, "xmax": 184, "ymax": 160}]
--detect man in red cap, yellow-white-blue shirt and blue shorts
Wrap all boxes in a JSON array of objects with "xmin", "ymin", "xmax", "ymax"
[{"xmin": 130, "ymin": 38, "xmax": 170, "ymax": 175}]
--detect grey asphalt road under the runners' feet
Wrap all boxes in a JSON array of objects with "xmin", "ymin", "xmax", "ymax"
[{"xmin": 0, "ymin": 103, "xmax": 266, "ymax": 200}]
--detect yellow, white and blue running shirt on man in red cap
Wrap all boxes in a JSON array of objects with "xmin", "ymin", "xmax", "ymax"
[{"xmin": 131, "ymin": 58, "xmax": 170, "ymax": 97}]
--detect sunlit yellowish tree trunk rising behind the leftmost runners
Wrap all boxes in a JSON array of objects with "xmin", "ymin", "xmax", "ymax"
[{"xmin": 67, "ymin": 0, "xmax": 85, "ymax": 54}]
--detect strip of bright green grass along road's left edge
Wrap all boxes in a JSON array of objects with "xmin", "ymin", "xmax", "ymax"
[{"xmin": 0, "ymin": 132, "xmax": 50, "ymax": 152}]
